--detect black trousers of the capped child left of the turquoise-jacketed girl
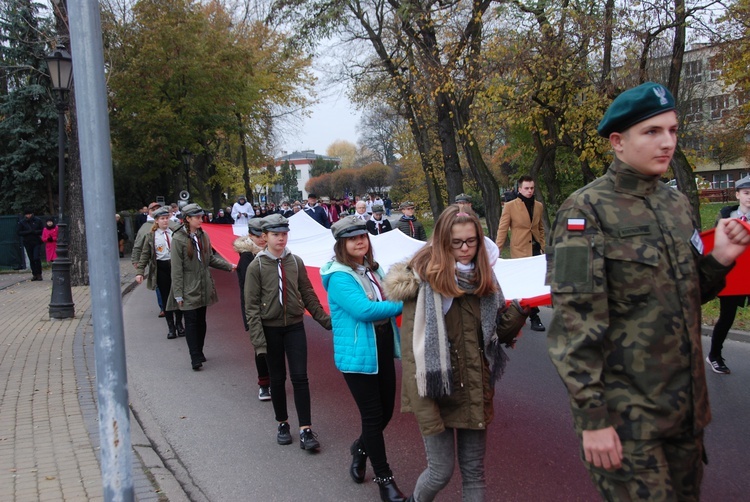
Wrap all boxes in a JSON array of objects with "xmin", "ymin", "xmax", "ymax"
[{"xmin": 263, "ymin": 322, "xmax": 312, "ymax": 426}]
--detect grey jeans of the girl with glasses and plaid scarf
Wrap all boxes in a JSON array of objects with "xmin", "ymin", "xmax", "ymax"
[{"xmin": 413, "ymin": 428, "xmax": 487, "ymax": 502}]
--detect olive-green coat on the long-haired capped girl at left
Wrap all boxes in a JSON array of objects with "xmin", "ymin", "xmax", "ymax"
[{"xmin": 166, "ymin": 226, "xmax": 232, "ymax": 310}]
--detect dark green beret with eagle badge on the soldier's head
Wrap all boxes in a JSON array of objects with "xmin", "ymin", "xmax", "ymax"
[{"xmin": 596, "ymin": 82, "xmax": 675, "ymax": 138}]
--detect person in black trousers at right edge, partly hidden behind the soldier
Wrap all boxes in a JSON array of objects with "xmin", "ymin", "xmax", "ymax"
[{"xmin": 706, "ymin": 176, "xmax": 750, "ymax": 375}]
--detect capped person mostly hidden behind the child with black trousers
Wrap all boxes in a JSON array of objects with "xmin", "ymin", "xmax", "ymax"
[{"xmin": 234, "ymin": 218, "xmax": 271, "ymax": 401}]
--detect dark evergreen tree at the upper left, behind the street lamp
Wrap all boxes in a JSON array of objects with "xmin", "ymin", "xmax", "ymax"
[{"xmin": 0, "ymin": 0, "xmax": 57, "ymax": 214}]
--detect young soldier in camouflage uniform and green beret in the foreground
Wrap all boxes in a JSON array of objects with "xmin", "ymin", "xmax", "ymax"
[{"xmin": 547, "ymin": 83, "xmax": 750, "ymax": 501}]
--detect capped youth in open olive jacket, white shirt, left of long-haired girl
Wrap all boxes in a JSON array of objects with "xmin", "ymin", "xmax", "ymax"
[{"xmin": 135, "ymin": 207, "xmax": 185, "ymax": 340}]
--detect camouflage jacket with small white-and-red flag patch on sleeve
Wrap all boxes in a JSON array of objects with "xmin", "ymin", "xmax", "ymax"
[{"xmin": 547, "ymin": 159, "xmax": 731, "ymax": 439}]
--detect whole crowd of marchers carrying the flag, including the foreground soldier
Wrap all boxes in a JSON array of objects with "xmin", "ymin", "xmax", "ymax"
[{"xmin": 125, "ymin": 83, "xmax": 750, "ymax": 502}]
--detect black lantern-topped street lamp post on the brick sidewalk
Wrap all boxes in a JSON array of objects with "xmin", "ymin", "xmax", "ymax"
[{"xmin": 46, "ymin": 47, "xmax": 75, "ymax": 319}]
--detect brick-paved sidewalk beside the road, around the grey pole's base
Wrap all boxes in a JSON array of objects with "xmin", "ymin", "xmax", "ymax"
[{"xmin": 0, "ymin": 258, "xmax": 187, "ymax": 502}]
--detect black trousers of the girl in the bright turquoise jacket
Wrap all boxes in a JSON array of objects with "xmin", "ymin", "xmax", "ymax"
[{"xmin": 344, "ymin": 322, "xmax": 396, "ymax": 477}]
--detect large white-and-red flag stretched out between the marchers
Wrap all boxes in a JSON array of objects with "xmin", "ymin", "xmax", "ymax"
[{"xmin": 203, "ymin": 211, "xmax": 550, "ymax": 310}]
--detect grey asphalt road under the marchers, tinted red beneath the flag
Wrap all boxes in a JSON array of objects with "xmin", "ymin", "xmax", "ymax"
[{"xmin": 124, "ymin": 271, "xmax": 750, "ymax": 501}]
